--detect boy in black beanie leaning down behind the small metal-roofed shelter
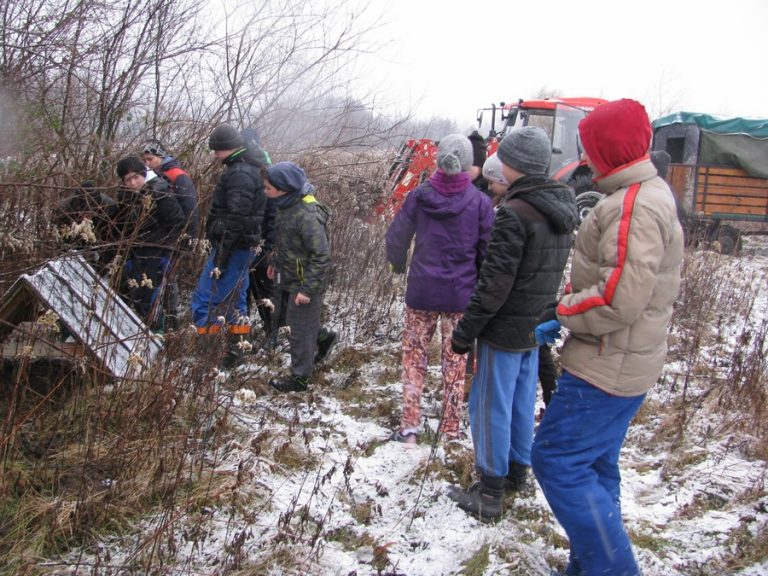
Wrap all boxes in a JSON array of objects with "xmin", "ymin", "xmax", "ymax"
[{"xmin": 115, "ymin": 156, "xmax": 185, "ymax": 330}]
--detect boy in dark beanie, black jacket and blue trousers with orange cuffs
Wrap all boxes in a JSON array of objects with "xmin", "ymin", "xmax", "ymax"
[{"xmin": 190, "ymin": 124, "xmax": 267, "ymax": 365}]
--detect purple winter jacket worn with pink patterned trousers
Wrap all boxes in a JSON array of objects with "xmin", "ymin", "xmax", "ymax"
[{"xmin": 386, "ymin": 174, "xmax": 493, "ymax": 312}]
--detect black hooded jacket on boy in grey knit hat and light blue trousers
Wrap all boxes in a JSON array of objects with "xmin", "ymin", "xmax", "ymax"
[{"xmin": 453, "ymin": 176, "xmax": 578, "ymax": 352}]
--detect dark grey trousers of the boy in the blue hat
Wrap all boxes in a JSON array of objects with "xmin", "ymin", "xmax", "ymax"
[{"xmin": 276, "ymin": 294, "xmax": 324, "ymax": 378}]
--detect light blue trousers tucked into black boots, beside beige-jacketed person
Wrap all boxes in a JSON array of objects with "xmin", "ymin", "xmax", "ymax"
[{"xmin": 468, "ymin": 340, "xmax": 539, "ymax": 477}]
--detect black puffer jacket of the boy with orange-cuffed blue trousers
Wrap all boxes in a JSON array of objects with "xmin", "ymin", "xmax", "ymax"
[{"xmin": 206, "ymin": 148, "xmax": 267, "ymax": 267}]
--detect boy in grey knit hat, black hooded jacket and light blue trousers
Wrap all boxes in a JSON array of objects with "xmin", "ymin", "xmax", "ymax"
[{"xmin": 449, "ymin": 126, "xmax": 578, "ymax": 520}]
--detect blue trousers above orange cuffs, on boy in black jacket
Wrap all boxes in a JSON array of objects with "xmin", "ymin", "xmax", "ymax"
[{"xmin": 190, "ymin": 250, "xmax": 254, "ymax": 328}]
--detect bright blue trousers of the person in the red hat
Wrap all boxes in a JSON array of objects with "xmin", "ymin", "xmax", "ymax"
[{"xmin": 531, "ymin": 372, "xmax": 645, "ymax": 576}]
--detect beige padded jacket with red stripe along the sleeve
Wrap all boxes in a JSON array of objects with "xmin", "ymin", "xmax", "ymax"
[{"xmin": 557, "ymin": 156, "xmax": 683, "ymax": 396}]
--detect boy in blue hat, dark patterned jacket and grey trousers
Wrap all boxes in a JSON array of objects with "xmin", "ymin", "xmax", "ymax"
[{"xmin": 264, "ymin": 162, "xmax": 337, "ymax": 392}]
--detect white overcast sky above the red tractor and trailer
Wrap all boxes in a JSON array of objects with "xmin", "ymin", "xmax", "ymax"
[{"xmin": 358, "ymin": 0, "xmax": 768, "ymax": 128}]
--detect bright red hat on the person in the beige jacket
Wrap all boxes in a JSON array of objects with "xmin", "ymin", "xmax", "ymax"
[{"xmin": 579, "ymin": 98, "xmax": 651, "ymax": 176}]
